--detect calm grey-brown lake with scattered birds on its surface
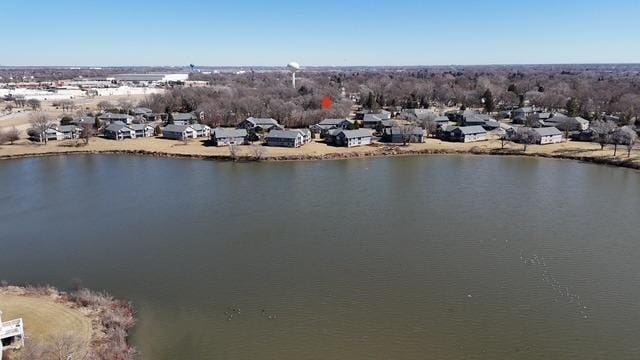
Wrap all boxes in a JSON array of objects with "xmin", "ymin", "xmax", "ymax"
[{"xmin": 0, "ymin": 155, "xmax": 640, "ymax": 359}]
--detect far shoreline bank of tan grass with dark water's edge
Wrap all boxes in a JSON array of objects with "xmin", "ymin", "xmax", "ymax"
[{"xmin": 0, "ymin": 139, "xmax": 640, "ymax": 170}]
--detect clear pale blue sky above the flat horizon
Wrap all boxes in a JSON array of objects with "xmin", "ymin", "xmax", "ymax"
[{"xmin": 0, "ymin": 0, "xmax": 640, "ymax": 66}]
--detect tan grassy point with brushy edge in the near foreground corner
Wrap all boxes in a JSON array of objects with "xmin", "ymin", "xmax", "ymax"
[{"xmin": 0, "ymin": 286, "xmax": 135, "ymax": 359}]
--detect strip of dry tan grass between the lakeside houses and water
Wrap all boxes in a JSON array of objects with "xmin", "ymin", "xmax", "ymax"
[{"xmin": 0, "ymin": 138, "xmax": 640, "ymax": 169}]
